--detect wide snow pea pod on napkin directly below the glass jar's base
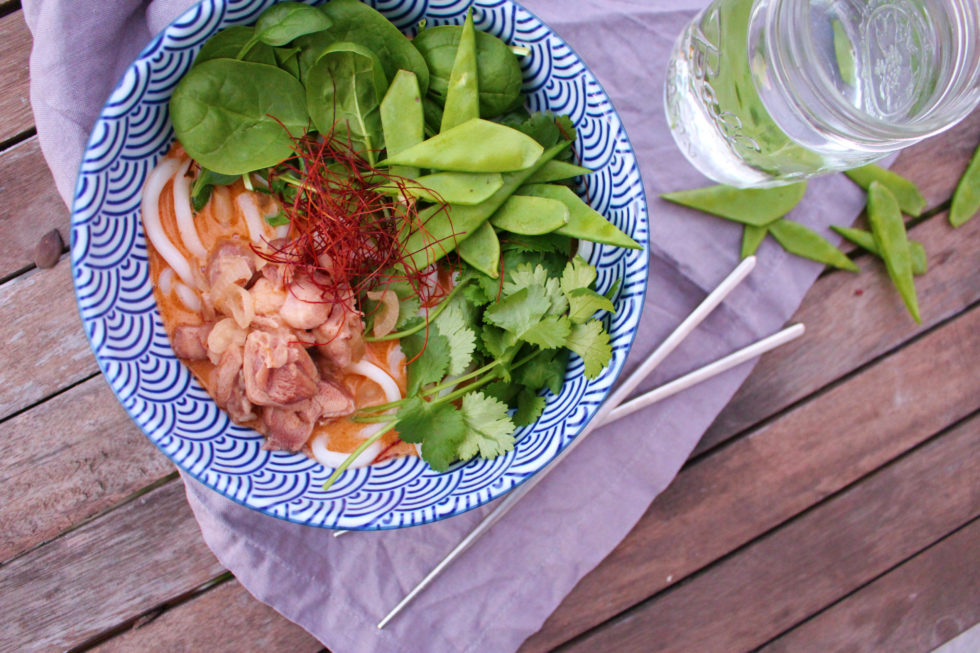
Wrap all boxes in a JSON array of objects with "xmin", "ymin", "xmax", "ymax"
[{"xmin": 660, "ymin": 181, "xmax": 806, "ymax": 227}]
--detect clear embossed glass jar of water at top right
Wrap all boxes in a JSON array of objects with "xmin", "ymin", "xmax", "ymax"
[{"xmin": 664, "ymin": 0, "xmax": 980, "ymax": 187}]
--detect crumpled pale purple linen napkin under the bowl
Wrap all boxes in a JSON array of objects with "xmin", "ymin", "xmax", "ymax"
[{"xmin": 24, "ymin": 0, "xmax": 863, "ymax": 653}]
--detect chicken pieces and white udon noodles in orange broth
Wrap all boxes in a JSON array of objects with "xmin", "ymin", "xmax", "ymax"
[{"xmin": 142, "ymin": 146, "xmax": 417, "ymax": 467}]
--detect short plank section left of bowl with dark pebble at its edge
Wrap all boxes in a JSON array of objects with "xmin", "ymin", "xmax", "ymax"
[{"xmin": 0, "ymin": 136, "xmax": 70, "ymax": 278}]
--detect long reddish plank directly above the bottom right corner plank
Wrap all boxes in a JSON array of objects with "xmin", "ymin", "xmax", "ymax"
[{"xmin": 566, "ymin": 417, "xmax": 980, "ymax": 653}]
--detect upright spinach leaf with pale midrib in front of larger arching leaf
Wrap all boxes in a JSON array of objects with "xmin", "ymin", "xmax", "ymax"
[{"xmin": 306, "ymin": 42, "xmax": 388, "ymax": 165}]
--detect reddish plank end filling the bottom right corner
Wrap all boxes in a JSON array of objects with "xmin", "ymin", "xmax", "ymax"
[{"xmin": 762, "ymin": 521, "xmax": 980, "ymax": 653}]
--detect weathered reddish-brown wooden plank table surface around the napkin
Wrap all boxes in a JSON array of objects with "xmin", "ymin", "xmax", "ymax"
[{"xmin": 0, "ymin": 6, "xmax": 980, "ymax": 653}]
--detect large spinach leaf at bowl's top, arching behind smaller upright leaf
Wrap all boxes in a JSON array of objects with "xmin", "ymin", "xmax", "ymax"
[{"xmin": 297, "ymin": 0, "xmax": 429, "ymax": 95}]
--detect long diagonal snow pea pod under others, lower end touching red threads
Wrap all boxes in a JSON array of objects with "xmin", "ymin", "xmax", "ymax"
[{"xmin": 405, "ymin": 141, "xmax": 571, "ymax": 270}]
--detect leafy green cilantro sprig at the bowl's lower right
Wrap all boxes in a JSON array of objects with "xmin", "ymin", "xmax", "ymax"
[{"xmin": 324, "ymin": 242, "xmax": 613, "ymax": 489}]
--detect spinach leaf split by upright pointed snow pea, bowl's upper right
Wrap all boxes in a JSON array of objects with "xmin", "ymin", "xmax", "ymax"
[{"xmin": 412, "ymin": 25, "xmax": 523, "ymax": 118}]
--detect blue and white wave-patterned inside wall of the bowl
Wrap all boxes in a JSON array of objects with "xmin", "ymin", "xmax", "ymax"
[{"xmin": 72, "ymin": 0, "xmax": 648, "ymax": 529}]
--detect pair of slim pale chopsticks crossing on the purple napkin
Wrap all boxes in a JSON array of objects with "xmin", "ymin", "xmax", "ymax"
[{"xmin": 335, "ymin": 256, "xmax": 804, "ymax": 629}]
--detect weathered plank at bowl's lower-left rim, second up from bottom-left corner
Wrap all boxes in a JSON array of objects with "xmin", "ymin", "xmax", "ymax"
[{"xmin": 0, "ymin": 376, "xmax": 174, "ymax": 563}]
